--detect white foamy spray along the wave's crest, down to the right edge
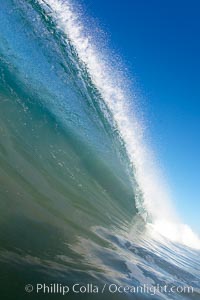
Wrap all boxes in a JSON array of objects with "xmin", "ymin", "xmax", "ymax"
[{"xmin": 38, "ymin": 0, "xmax": 200, "ymax": 248}]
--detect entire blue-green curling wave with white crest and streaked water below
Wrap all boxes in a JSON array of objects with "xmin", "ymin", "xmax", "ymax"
[{"xmin": 0, "ymin": 0, "xmax": 200, "ymax": 299}]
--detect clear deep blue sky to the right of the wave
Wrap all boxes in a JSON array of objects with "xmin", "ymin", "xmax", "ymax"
[{"xmin": 82, "ymin": 0, "xmax": 200, "ymax": 233}]
